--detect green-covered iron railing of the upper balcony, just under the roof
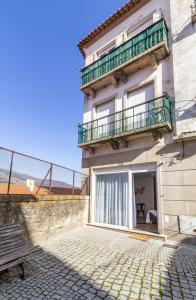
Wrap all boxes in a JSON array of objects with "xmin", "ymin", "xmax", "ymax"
[{"xmin": 81, "ymin": 19, "xmax": 168, "ymax": 86}]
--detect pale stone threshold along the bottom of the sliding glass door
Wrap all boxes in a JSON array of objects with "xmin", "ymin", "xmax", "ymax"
[{"xmin": 86, "ymin": 223, "xmax": 167, "ymax": 242}]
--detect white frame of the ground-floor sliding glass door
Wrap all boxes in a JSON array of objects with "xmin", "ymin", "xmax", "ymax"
[{"xmin": 90, "ymin": 164, "xmax": 159, "ymax": 229}]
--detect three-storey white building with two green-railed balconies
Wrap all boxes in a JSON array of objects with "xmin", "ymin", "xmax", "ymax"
[{"xmin": 78, "ymin": 0, "xmax": 196, "ymax": 239}]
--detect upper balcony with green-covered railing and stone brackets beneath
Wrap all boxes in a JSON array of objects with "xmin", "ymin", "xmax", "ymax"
[{"xmin": 81, "ymin": 19, "xmax": 169, "ymax": 92}]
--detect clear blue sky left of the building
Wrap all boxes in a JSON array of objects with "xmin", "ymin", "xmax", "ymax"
[{"xmin": 0, "ymin": 0, "xmax": 126, "ymax": 170}]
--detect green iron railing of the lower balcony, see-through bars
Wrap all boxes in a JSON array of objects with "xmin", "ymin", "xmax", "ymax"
[{"xmin": 78, "ymin": 94, "xmax": 172, "ymax": 145}]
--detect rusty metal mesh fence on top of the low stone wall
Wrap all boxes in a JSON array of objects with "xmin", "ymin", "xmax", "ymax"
[{"xmin": 0, "ymin": 147, "xmax": 89, "ymax": 195}]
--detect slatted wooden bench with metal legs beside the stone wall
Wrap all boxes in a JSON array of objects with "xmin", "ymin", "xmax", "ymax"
[{"xmin": 0, "ymin": 224, "xmax": 41, "ymax": 280}]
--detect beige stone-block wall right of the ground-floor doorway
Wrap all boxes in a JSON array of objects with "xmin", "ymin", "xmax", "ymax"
[{"xmin": 160, "ymin": 141, "xmax": 196, "ymax": 240}]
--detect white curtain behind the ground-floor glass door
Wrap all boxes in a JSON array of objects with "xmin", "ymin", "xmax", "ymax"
[{"xmin": 94, "ymin": 173, "xmax": 128, "ymax": 227}]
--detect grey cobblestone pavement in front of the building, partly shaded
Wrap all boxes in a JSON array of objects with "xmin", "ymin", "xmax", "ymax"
[{"xmin": 0, "ymin": 227, "xmax": 196, "ymax": 300}]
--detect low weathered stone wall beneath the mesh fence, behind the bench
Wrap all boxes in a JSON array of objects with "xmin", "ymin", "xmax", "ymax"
[{"xmin": 0, "ymin": 195, "xmax": 89, "ymax": 244}]
